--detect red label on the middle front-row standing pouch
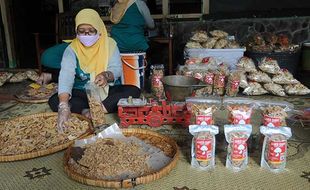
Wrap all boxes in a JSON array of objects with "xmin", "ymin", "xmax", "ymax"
[{"xmin": 231, "ymin": 138, "xmax": 247, "ymax": 160}]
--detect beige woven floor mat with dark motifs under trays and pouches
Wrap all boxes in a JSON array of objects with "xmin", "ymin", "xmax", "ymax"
[{"xmin": 0, "ymin": 97, "xmax": 310, "ymax": 190}]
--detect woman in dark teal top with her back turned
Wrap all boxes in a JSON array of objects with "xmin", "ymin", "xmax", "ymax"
[{"xmin": 110, "ymin": 0, "xmax": 155, "ymax": 53}]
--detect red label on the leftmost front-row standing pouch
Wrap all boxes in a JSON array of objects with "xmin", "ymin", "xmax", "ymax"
[{"xmin": 195, "ymin": 139, "xmax": 212, "ymax": 161}]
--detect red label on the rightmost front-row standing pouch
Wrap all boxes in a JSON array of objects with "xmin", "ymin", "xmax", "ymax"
[{"xmin": 268, "ymin": 141, "xmax": 286, "ymax": 163}]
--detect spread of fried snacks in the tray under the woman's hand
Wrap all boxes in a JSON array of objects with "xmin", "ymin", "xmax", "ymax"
[{"xmin": 0, "ymin": 115, "xmax": 89, "ymax": 155}]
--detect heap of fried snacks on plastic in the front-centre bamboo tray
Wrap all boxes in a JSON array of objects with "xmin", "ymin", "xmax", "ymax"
[{"xmin": 69, "ymin": 138, "xmax": 151, "ymax": 180}]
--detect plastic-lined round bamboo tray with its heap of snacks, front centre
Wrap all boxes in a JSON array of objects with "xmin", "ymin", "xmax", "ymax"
[{"xmin": 64, "ymin": 124, "xmax": 179, "ymax": 188}]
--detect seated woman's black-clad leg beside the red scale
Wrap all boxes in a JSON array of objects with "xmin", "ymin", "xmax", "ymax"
[{"xmin": 102, "ymin": 85, "xmax": 141, "ymax": 113}]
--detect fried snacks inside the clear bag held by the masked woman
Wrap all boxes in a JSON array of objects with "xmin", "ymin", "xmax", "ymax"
[{"xmin": 87, "ymin": 95, "xmax": 106, "ymax": 127}]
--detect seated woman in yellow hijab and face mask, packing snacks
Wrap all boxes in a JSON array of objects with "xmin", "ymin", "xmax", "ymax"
[{"xmin": 49, "ymin": 9, "xmax": 140, "ymax": 131}]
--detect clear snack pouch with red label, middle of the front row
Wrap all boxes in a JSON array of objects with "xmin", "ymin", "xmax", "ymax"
[{"xmin": 224, "ymin": 125, "xmax": 252, "ymax": 172}]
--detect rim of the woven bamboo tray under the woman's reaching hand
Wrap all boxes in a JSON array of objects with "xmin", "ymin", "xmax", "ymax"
[{"xmin": 0, "ymin": 112, "xmax": 92, "ymax": 162}]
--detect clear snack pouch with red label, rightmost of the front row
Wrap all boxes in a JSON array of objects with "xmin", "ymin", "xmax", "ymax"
[{"xmin": 260, "ymin": 126, "xmax": 292, "ymax": 172}]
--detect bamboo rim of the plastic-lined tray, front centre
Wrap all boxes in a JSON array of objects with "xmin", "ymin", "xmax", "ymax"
[{"xmin": 64, "ymin": 129, "xmax": 179, "ymax": 188}]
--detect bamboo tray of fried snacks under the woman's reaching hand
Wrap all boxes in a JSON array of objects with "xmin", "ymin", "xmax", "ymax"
[{"xmin": 0, "ymin": 113, "xmax": 92, "ymax": 162}]
